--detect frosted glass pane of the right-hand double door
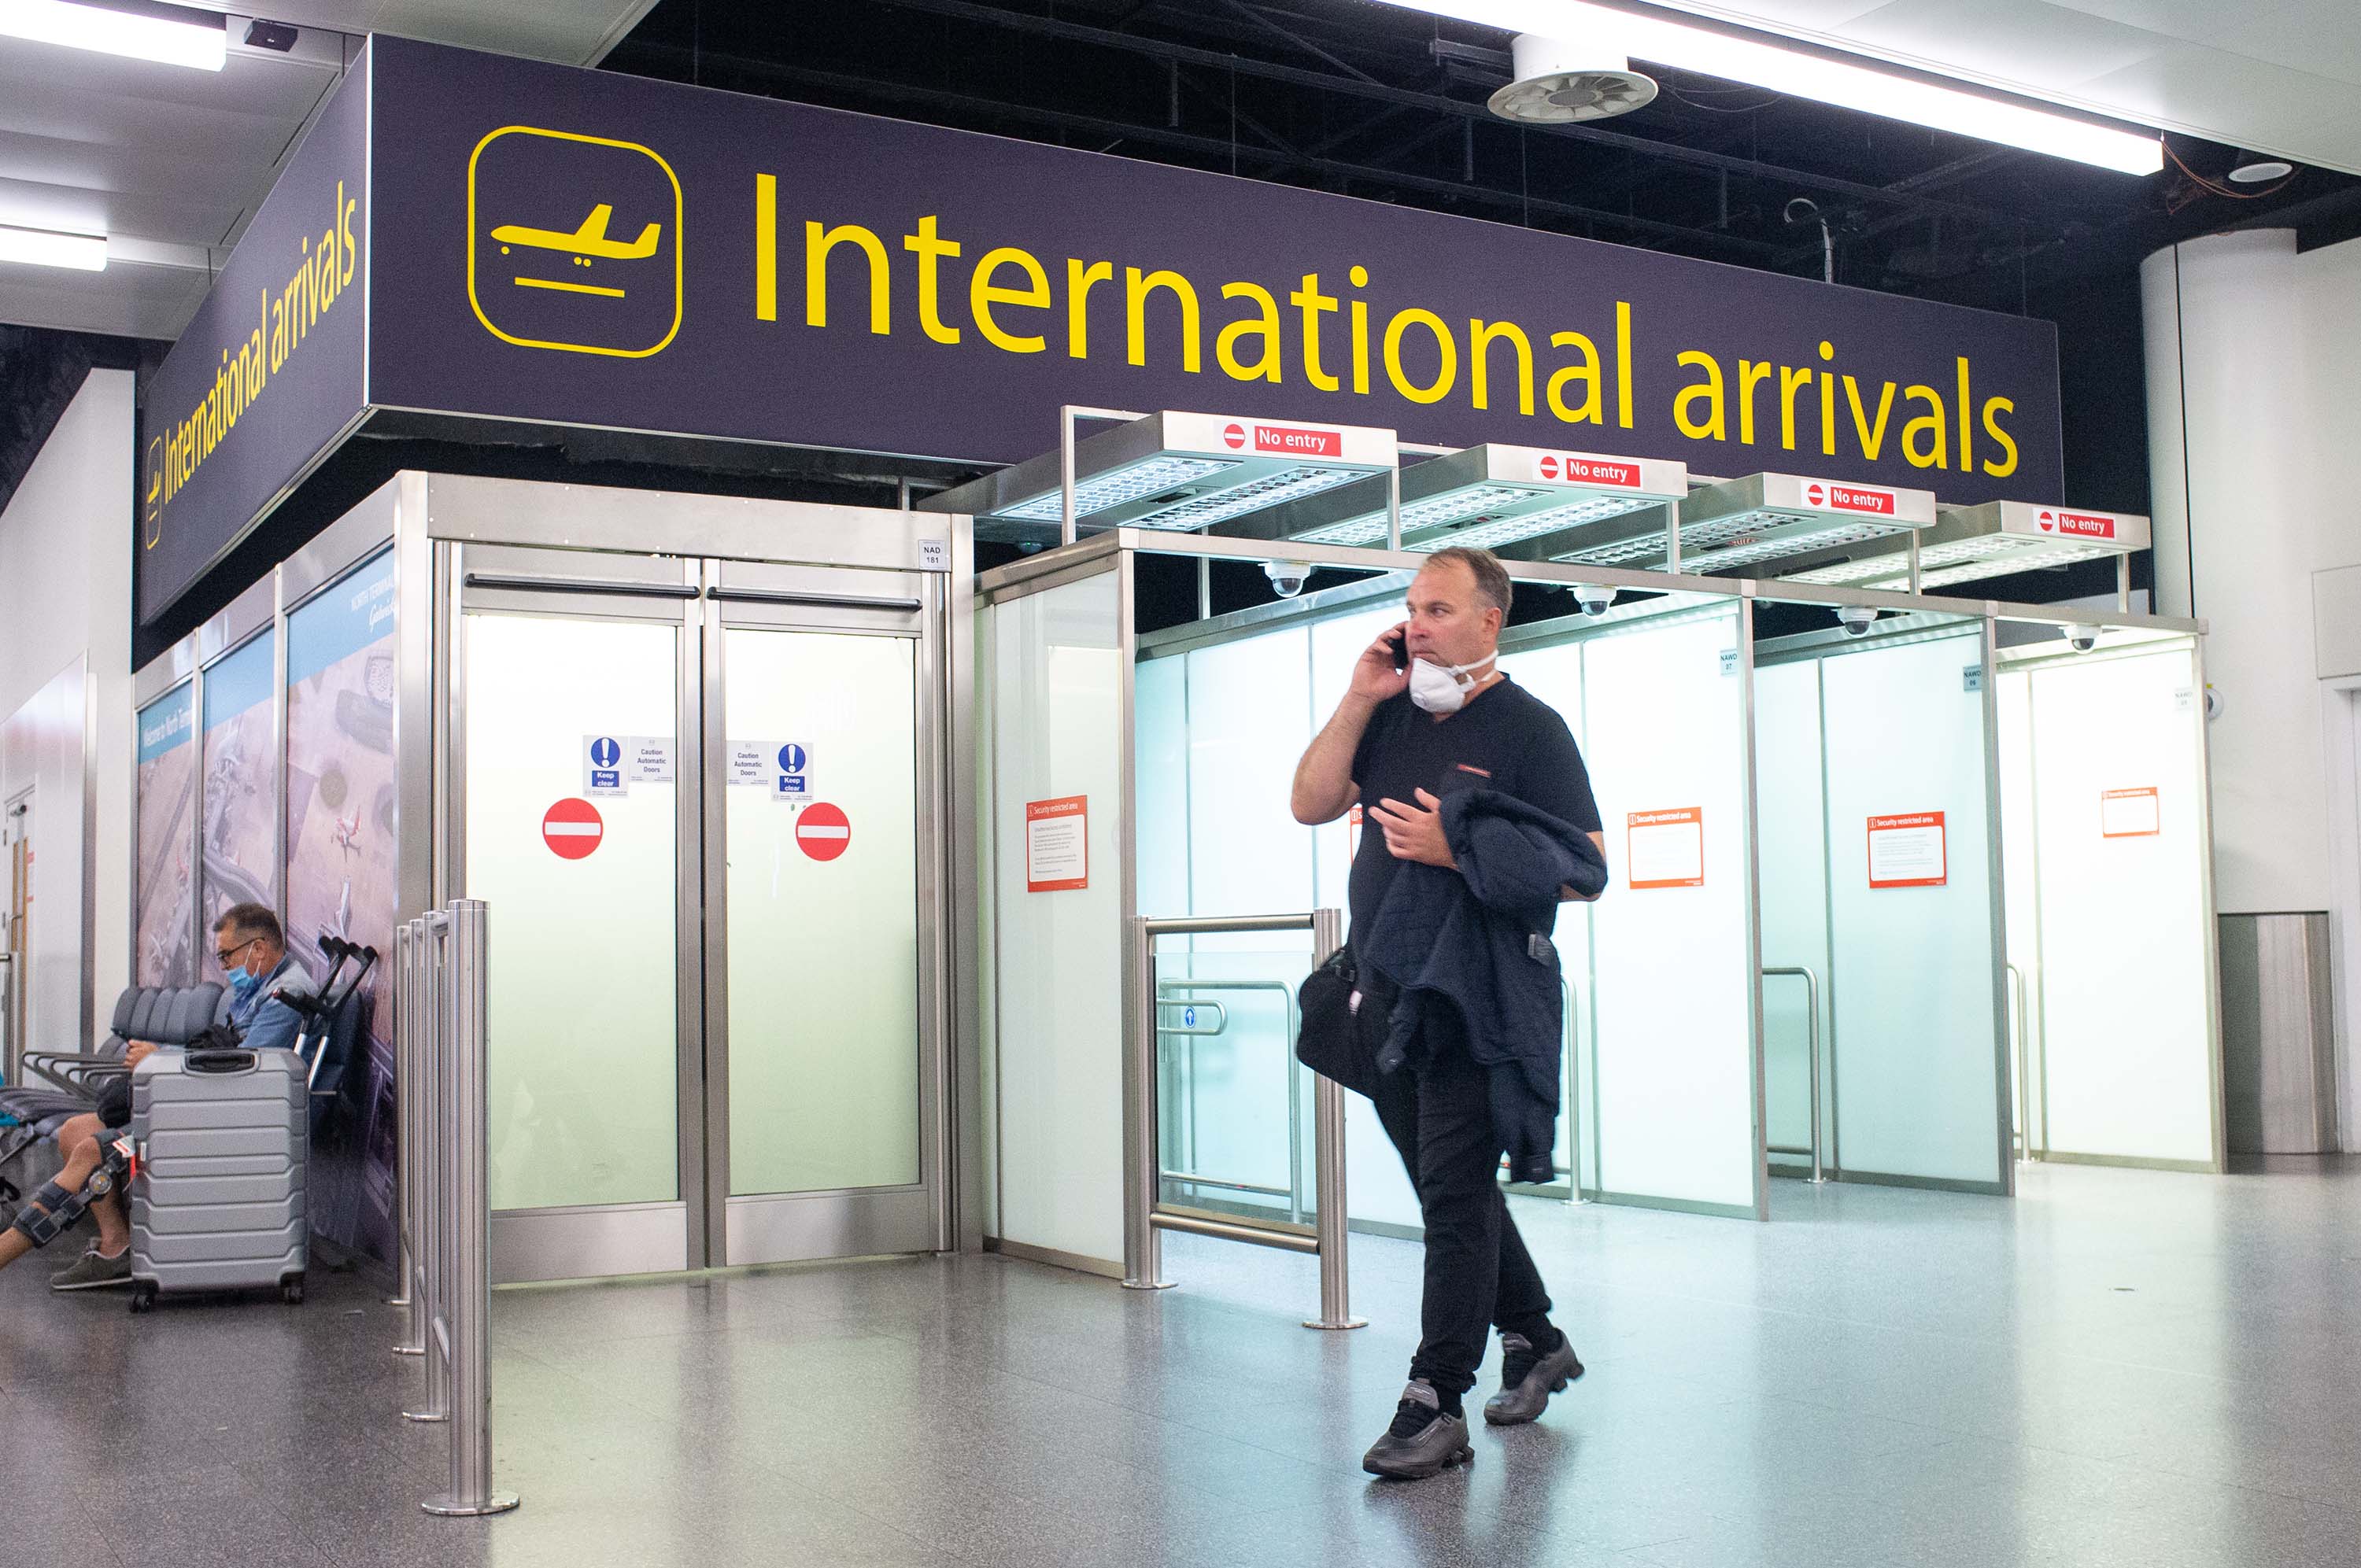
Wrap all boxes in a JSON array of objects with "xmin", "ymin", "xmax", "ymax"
[{"xmin": 722, "ymin": 628, "xmax": 918, "ymax": 1195}]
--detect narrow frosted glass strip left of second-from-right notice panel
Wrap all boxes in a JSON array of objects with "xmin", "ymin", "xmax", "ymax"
[{"xmin": 1754, "ymin": 659, "xmax": 1832, "ymax": 1167}]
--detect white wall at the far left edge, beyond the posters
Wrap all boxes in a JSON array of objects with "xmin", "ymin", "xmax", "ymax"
[{"xmin": 0, "ymin": 371, "xmax": 132, "ymax": 1049}]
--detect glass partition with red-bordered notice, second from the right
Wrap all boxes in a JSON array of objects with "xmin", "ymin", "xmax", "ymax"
[{"xmin": 1757, "ymin": 604, "xmax": 2007, "ymax": 1188}]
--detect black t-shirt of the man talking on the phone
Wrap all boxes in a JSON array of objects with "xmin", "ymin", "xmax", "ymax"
[{"xmin": 1350, "ymin": 675, "xmax": 1601, "ymax": 944}]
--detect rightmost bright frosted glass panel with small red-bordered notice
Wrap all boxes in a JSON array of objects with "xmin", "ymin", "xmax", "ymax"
[{"xmin": 2030, "ymin": 649, "xmax": 2215, "ymax": 1164}]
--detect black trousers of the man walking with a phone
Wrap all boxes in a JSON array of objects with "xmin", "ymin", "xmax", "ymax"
[{"xmin": 1362, "ymin": 1024, "xmax": 1551, "ymax": 1396}]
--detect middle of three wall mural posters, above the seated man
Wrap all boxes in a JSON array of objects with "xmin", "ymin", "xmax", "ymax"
[{"xmin": 203, "ymin": 633, "xmax": 277, "ymax": 935}]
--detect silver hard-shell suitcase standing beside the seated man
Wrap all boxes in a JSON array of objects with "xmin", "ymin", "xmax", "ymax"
[{"xmin": 132, "ymin": 1049, "xmax": 309, "ymax": 1313}]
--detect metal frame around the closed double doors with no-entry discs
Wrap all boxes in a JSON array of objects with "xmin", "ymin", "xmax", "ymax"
[{"xmin": 401, "ymin": 472, "xmax": 982, "ymax": 1282}]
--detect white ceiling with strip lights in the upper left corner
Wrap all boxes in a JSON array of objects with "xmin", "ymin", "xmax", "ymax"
[{"xmin": 0, "ymin": 0, "xmax": 654, "ymax": 338}]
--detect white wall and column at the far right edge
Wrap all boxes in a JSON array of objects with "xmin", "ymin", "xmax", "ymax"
[{"xmin": 2141, "ymin": 229, "xmax": 2361, "ymax": 1148}]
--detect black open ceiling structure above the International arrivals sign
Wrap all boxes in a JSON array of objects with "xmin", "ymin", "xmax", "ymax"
[{"xmin": 604, "ymin": 0, "xmax": 2361, "ymax": 609}]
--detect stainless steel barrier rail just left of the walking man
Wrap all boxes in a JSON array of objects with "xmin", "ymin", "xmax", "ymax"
[{"xmin": 1124, "ymin": 909, "xmax": 1367, "ymax": 1330}]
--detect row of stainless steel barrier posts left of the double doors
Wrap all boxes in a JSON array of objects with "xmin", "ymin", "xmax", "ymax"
[{"xmin": 394, "ymin": 898, "xmax": 517, "ymax": 1518}]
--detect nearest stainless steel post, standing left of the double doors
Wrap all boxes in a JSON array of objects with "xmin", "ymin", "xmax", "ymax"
[{"xmin": 418, "ymin": 898, "xmax": 517, "ymax": 1518}]
